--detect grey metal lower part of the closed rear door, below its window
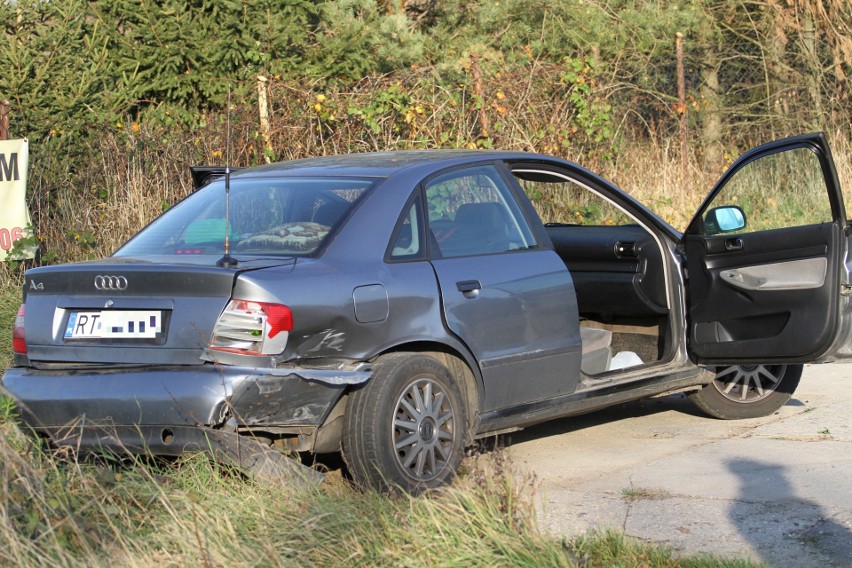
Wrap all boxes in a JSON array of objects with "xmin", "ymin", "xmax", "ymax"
[{"xmin": 432, "ymin": 250, "xmax": 581, "ymax": 410}]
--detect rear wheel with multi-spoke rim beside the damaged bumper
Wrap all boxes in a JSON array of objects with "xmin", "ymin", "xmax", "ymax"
[{"xmin": 343, "ymin": 353, "xmax": 466, "ymax": 494}]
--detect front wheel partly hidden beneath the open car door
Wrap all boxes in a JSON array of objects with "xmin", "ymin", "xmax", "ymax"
[{"xmin": 687, "ymin": 365, "xmax": 803, "ymax": 420}]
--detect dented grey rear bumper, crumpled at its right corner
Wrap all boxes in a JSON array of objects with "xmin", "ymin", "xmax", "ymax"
[{"xmin": 0, "ymin": 365, "xmax": 370, "ymax": 455}]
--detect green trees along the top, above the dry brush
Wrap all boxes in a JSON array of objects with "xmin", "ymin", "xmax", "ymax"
[{"xmin": 0, "ymin": 0, "xmax": 852, "ymax": 146}]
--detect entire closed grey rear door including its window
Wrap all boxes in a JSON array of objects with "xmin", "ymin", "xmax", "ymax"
[{"xmin": 423, "ymin": 163, "xmax": 581, "ymax": 411}]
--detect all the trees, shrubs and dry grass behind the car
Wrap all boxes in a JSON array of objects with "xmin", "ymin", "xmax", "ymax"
[{"xmin": 0, "ymin": 0, "xmax": 852, "ymax": 261}]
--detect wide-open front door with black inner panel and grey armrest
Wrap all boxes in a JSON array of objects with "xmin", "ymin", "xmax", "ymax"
[{"xmin": 683, "ymin": 135, "xmax": 848, "ymax": 364}]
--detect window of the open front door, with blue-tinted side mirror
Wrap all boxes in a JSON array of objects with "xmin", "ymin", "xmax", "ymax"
[{"xmin": 701, "ymin": 148, "xmax": 832, "ymax": 235}]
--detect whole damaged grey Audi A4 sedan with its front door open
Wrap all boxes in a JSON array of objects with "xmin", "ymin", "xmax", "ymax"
[{"xmin": 0, "ymin": 134, "xmax": 852, "ymax": 492}]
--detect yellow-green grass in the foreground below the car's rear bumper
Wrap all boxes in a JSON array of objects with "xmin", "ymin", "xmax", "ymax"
[{"xmin": 0, "ymin": 273, "xmax": 764, "ymax": 567}]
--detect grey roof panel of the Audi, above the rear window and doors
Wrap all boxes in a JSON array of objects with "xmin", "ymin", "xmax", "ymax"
[{"xmin": 232, "ymin": 150, "xmax": 544, "ymax": 178}]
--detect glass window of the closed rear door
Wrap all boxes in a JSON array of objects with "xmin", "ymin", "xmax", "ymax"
[{"xmin": 426, "ymin": 166, "xmax": 536, "ymax": 258}]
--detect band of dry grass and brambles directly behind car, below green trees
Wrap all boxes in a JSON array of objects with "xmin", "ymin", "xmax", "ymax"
[{"xmin": 21, "ymin": 64, "xmax": 852, "ymax": 262}]
